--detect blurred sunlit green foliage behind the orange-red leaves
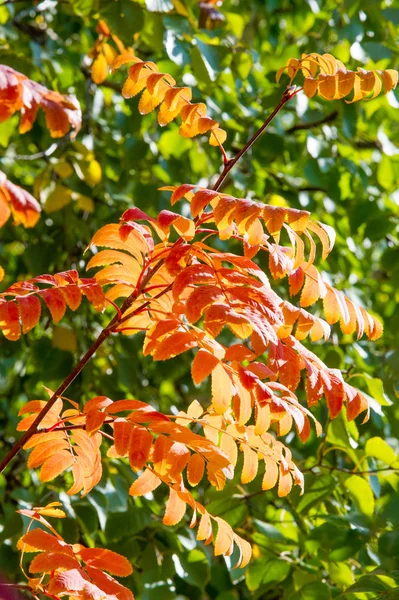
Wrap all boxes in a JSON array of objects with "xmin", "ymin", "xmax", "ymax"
[{"xmin": 0, "ymin": 0, "xmax": 399, "ymax": 600}]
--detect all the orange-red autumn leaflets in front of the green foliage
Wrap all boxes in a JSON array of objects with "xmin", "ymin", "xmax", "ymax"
[{"xmin": 0, "ymin": 31, "xmax": 397, "ymax": 600}]
